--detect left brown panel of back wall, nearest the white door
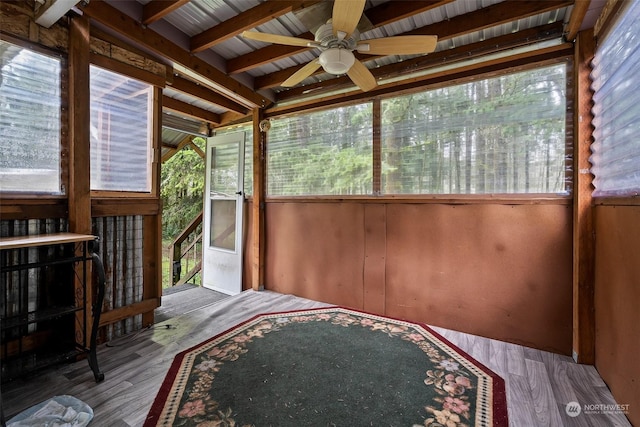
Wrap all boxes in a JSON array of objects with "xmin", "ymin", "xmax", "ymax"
[{"xmin": 265, "ymin": 203, "xmax": 365, "ymax": 309}]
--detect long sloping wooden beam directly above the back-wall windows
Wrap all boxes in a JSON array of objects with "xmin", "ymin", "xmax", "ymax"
[{"xmin": 265, "ymin": 43, "xmax": 573, "ymax": 118}]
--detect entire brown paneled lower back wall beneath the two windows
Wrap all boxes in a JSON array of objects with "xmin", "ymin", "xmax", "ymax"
[{"xmin": 265, "ymin": 201, "xmax": 572, "ymax": 354}]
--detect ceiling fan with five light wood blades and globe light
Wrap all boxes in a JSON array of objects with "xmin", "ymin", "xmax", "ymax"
[{"xmin": 242, "ymin": 0, "xmax": 438, "ymax": 92}]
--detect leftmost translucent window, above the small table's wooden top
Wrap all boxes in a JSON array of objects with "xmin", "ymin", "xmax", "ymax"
[{"xmin": 0, "ymin": 40, "xmax": 62, "ymax": 194}]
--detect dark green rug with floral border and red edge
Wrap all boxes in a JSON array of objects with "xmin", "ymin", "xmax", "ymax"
[{"xmin": 145, "ymin": 307, "xmax": 508, "ymax": 427}]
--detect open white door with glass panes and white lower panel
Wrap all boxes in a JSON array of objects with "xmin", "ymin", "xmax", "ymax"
[{"xmin": 202, "ymin": 132, "xmax": 245, "ymax": 295}]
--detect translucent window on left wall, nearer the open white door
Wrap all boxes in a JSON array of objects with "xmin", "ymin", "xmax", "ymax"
[{"xmin": 90, "ymin": 65, "xmax": 153, "ymax": 192}]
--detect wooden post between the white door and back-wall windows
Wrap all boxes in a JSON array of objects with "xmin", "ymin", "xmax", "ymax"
[{"xmin": 251, "ymin": 108, "xmax": 267, "ymax": 291}]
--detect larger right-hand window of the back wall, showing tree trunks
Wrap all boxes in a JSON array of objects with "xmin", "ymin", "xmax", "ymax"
[{"xmin": 381, "ymin": 64, "xmax": 571, "ymax": 194}]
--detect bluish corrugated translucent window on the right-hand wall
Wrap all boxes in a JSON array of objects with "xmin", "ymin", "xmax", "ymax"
[{"xmin": 590, "ymin": 2, "xmax": 640, "ymax": 196}]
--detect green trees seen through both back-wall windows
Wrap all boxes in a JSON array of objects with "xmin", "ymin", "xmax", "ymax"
[{"xmin": 267, "ymin": 64, "xmax": 570, "ymax": 196}]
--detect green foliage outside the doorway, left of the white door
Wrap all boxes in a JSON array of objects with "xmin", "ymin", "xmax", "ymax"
[{"xmin": 160, "ymin": 138, "xmax": 206, "ymax": 240}]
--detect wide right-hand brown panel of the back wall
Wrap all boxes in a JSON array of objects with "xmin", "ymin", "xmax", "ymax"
[{"xmin": 386, "ymin": 205, "xmax": 572, "ymax": 355}]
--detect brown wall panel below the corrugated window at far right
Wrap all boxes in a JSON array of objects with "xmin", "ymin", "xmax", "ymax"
[{"xmin": 594, "ymin": 206, "xmax": 640, "ymax": 425}]
